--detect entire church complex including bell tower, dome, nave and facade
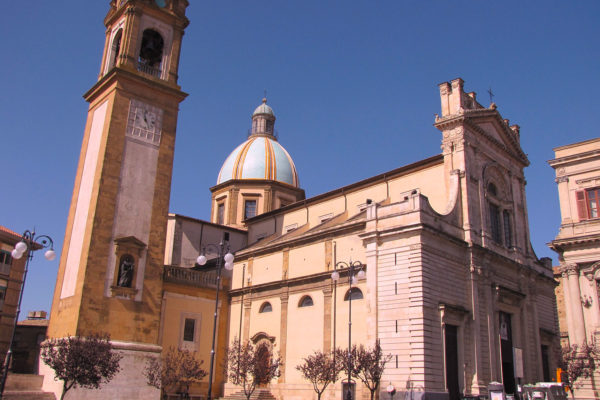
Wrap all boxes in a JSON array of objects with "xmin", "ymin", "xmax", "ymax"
[{"xmin": 40, "ymin": 0, "xmax": 558, "ymax": 399}]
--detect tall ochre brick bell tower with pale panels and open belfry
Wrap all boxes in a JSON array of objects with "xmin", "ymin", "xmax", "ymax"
[{"xmin": 44, "ymin": 0, "xmax": 189, "ymax": 399}]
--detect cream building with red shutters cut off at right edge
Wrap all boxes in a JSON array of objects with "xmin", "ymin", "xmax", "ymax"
[{"xmin": 548, "ymin": 139, "xmax": 600, "ymax": 398}]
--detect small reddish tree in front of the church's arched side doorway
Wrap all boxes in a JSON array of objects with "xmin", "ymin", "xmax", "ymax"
[{"xmin": 227, "ymin": 338, "xmax": 282, "ymax": 400}]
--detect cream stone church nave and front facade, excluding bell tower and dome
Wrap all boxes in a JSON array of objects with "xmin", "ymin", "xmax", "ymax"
[{"xmin": 219, "ymin": 79, "xmax": 558, "ymax": 399}]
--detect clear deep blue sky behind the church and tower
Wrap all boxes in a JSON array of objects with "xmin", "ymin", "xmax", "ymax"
[{"xmin": 0, "ymin": 0, "xmax": 600, "ymax": 315}]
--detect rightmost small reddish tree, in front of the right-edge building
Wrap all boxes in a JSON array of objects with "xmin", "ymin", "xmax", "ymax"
[{"xmin": 560, "ymin": 343, "xmax": 600, "ymax": 398}]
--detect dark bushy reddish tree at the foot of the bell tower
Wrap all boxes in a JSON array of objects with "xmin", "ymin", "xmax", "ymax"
[{"xmin": 41, "ymin": 334, "xmax": 123, "ymax": 400}]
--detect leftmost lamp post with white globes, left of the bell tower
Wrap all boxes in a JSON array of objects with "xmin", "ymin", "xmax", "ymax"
[{"xmin": 0, "ymin": 230, "xmax": 56, "ymax": 399}]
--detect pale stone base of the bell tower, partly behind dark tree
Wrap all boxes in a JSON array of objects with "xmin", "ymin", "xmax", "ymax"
[{"xmin": 39, "ymin": 341, "xmax": 162, "ymax": 400}]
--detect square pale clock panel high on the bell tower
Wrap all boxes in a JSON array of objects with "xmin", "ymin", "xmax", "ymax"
[{"xmin": 127, "ymin": 100, "xmax": 163, "ymax": 146}]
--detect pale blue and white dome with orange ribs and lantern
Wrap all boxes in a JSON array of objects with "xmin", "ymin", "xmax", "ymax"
[{"xmin": 217, "ymin": 99, "xmax": 299, "ymax": 187}]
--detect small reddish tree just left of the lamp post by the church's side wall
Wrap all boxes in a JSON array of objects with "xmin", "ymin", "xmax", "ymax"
[{"xmin": 296, "ymin": 351, "xmax": 343, "ymax": 400}]
